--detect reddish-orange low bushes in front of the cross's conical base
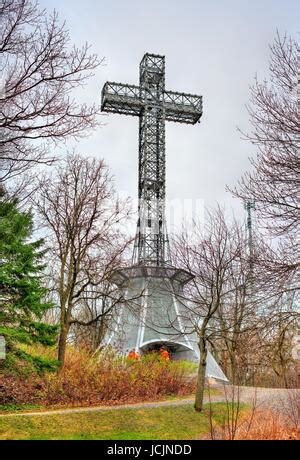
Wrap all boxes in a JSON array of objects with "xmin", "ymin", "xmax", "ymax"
[{"xmin": 0, "ymin": 349, "xmax": 195, "ymax": 405}]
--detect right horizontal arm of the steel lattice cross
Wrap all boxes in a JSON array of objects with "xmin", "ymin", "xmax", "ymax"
[{"xmin": 164, "ymin": 91, "xmax": 202, "ymax": 124}]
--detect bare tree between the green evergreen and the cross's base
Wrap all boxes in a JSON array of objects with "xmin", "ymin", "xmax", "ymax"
[{"xmin": 34, "ymin": 155, "xmax": 129, "ymax": 366}]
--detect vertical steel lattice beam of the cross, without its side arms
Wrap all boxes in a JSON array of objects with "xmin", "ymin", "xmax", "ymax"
[{"xmin": 134, "ymin": 54, "xmax": 171, "ymax": 265}]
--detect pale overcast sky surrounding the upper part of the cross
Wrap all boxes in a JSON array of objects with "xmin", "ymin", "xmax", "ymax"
[{"xmin": 40, "ymin": 0, "xmax": 299, "ymax": 230}]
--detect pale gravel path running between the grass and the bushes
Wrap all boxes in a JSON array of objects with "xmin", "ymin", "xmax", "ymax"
[{"xmin": 0, "ymin": 385, "xmax": 300, "ymax": 418}]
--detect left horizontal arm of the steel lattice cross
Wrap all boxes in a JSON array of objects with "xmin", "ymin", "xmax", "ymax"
[{"xmin": 101, "ymin": 81, "xmax": 143, "ymax": 116}]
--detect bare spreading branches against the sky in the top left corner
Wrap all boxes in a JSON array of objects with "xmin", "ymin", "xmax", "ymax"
[{"xmin": 0, "ymin": 0, "xmax": 100, "ymax": 187}]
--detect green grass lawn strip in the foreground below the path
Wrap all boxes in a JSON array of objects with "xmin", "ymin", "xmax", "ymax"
[{"xmin": 0, "ymin": 403, "xmax": 240, "ymax": 440}]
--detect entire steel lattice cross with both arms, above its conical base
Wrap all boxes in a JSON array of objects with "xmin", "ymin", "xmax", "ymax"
[{"xmin": 101, "ymin": 53, "xmax": 202, "ymax": 266}]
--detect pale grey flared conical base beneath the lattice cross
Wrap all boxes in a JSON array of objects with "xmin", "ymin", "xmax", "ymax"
[{"xmin": 106, "ymin": 267, "xmax": 228, "ymax": 381}]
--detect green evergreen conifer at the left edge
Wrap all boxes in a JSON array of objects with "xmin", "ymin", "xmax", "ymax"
[{"xmin": 0, "ymin": 193, "xmax": 57, "ymax": 368}]
